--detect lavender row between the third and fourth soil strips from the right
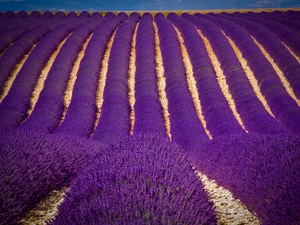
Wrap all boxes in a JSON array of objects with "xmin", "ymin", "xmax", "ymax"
[{"xmin": 182, "ymin": 14, "xmax": 286, "ymax": 133}]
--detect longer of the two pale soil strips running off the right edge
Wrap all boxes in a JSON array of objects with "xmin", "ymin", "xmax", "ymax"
[{"xmin": 251, "ymin": 36, "xmax": 300, "ymax": 106}]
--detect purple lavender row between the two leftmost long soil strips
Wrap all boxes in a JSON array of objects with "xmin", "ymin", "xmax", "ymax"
[{"xmin": 0, "ymin": 20, "xmax": 88, "ymax": 134}]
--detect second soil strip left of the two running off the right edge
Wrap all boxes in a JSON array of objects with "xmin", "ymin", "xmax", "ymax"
[{"xmin": 197, "ymin": 29, "xmax": 248, "ymax": 133}]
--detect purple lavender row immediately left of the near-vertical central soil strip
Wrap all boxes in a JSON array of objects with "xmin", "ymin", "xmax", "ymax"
[{"xmin": 92, "ymin": 13, "xmax": 140, "ymax": 143}]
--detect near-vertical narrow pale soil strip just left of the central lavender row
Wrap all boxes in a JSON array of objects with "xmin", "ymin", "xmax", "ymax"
[{"xmin": 128, "ymin": 23, "xmax": 139, "ymax": 134}]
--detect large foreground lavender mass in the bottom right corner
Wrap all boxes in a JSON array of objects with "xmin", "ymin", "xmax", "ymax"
[{"xmin": 188, "ymin": 134, "xmax": 300, "ymax": 225}]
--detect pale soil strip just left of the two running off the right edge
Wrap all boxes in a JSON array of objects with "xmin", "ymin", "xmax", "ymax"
[{"xmin": 224, "ymin": 34, "xmax": 275, "ymax": 118}]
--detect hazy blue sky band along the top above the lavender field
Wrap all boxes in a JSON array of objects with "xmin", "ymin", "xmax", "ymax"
[{"xmin": 0, "ymin": 0, "xmax": 300, "ymax": 12}]
